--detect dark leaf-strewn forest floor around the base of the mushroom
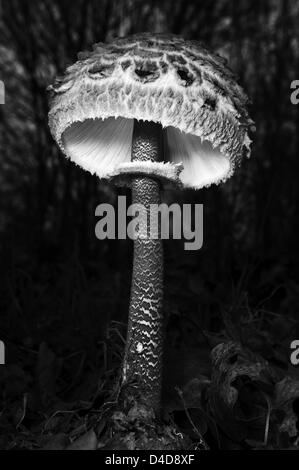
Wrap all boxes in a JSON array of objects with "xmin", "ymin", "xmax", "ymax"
[{"xmin": 0, "ymin": 250, "xmax": 299, "ymax": 449}]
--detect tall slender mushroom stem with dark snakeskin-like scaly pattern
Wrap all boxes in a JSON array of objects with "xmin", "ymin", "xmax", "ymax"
[{"xmin": 123, "ymin": 121, "xmax": 163, "ymax": 411}]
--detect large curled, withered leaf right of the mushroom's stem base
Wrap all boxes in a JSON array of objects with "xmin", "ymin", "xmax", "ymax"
[{"xmin": 208, "ymin": 341, "xmax": 274, "ymax": 442}]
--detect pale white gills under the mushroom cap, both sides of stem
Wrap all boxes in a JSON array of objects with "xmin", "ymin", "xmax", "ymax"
[{"xmin": 63, "ymin": 117, "xmax": 230, "ymax": 189}]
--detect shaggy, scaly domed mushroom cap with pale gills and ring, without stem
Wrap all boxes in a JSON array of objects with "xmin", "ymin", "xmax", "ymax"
[{"xmin": 49, "ymin": 33, "xmax": 253, "ymax": 189}]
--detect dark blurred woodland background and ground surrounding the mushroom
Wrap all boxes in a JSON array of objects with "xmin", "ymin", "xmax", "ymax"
[{"xmin": 0, "ymin": 0, "xmax": 299, "ymax": 449}]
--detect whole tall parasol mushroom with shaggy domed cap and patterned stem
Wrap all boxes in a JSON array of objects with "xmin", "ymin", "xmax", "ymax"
[{"xmin": 49, "ymin": 33, "xmax": 253, "ymax": 411}]
